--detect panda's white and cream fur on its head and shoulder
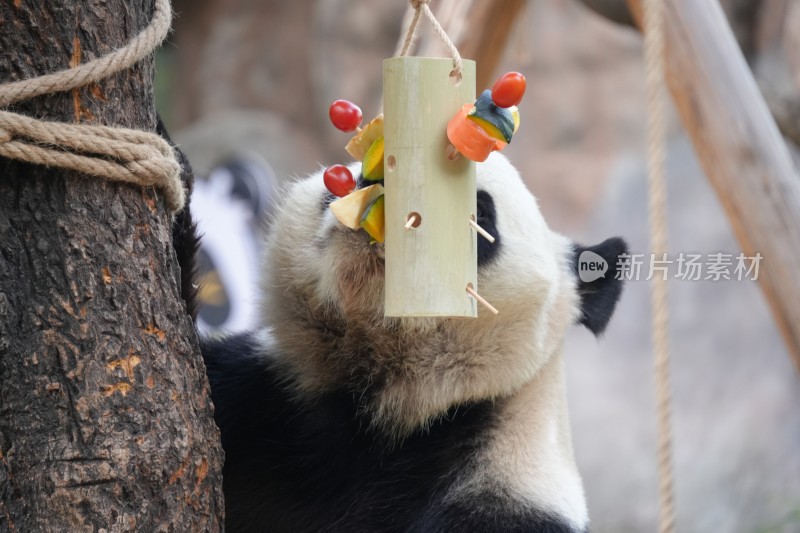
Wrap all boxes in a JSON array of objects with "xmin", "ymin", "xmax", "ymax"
[{"xmin": 200, "ymin": 154, "xmax": 618, "ymax": 531}]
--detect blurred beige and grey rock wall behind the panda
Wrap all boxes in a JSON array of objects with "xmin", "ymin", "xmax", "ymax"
[{"xmin": 157, "ymin": 0, "xmax": 800, "ymax": 532}]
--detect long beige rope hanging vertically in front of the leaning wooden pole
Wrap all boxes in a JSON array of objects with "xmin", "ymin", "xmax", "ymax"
[{"xmin": 644, "ymin": 0, "xmax": 675, "ymax": 533}]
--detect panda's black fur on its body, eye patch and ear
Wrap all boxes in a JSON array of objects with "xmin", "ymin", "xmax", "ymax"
[{"xmin": 159, "ymin": 125, "xmax": 626, "ymax": 533}]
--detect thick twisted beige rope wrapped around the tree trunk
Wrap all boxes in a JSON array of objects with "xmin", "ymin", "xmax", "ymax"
[{"xmin": 0, "ymin": 0, "xmax": 186, "ymax": 212}]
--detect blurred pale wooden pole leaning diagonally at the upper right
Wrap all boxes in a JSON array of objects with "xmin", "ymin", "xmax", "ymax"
[{"xmin": 627, "ymin": 0, "xmax": 800, "ymax": 369}]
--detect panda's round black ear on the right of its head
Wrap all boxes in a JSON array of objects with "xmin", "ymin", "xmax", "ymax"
[{"xmin": 573, "ymin": 237, "xmax": 628, "ymax": 335}]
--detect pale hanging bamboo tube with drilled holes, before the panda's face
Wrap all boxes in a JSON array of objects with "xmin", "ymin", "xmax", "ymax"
[{"xmin": 383, "ymin": 57, "xmax": 478, "ymax": 317}]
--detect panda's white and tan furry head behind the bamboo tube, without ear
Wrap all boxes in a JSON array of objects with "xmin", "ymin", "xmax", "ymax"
[{"xmin": 264, "ymin": 154, "xmax": 615, "ymax": 427}]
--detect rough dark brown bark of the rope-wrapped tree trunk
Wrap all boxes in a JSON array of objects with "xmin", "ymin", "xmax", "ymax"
[{"xmin": 0, "ymin": 0, "xmax": 223, "ymax": 532}]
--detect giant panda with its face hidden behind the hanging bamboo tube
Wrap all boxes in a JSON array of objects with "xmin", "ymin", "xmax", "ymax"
[{"xmin": 197, "ymin": 153, "xmax": 626, "ymax": 533}]
